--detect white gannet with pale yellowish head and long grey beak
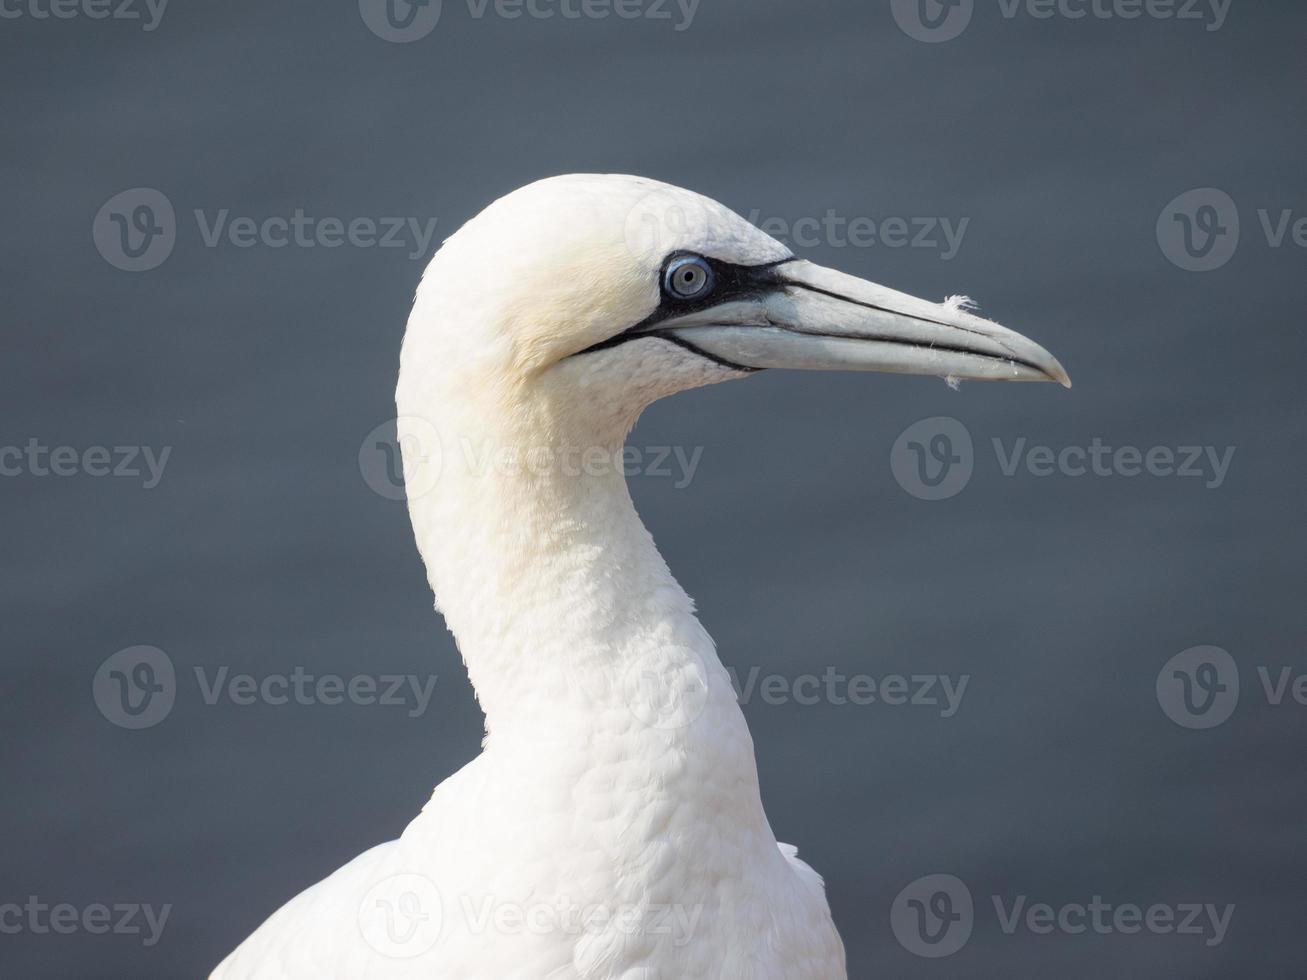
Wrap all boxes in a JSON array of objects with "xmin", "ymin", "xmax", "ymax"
[{"xmin": 213, "ymin": 175, "xmax": 1069, "ymax": 980}]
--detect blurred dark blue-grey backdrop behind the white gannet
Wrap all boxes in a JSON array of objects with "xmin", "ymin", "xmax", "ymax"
[{"xmin": 0, "ymin": 0, "xmax": 1307, "ymax": 980}]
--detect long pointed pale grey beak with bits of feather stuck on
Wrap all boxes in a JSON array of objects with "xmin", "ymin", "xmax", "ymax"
[{"xmin": 657, "ymin": 260, "xmax": 1070, "ymax": 388}]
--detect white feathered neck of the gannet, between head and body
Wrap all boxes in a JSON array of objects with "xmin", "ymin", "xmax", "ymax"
[{"xmin": 399, "ymin": 358, "xmax": 762, "ymax": 789}]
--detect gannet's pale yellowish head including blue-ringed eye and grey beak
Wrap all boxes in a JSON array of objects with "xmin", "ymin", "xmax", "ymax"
[{"xmin": 400, "ymin": 174, "xmax": 1070, "ymax": 441}]
